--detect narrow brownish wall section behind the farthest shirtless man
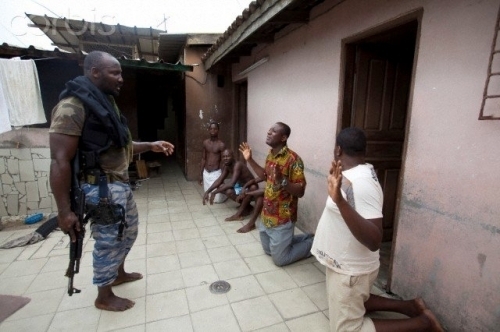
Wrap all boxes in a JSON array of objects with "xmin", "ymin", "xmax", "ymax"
[{"xmin": 185, "ymin": 47, "xmax": 237, "ymax": 180}]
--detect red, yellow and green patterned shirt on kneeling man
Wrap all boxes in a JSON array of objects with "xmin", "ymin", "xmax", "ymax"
[{"xmin": 261, "ymin": 146, "xmax": 306, "ymax": 228}]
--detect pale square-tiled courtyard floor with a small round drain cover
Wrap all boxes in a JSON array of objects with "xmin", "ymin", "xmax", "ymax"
[{"xmin": 0, "ymin": 162, "xmax": 390, "ymax": 332}]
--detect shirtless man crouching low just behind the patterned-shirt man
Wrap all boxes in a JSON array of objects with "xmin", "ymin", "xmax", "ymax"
[{"xmin": 203, "ymin": 149, "xmax": 263, "ymax": 233}]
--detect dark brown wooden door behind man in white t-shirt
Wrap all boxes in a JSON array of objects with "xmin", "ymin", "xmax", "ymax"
[{"xmin": 344, "ymin": 43, "xmax": 414, "ymax": 241}]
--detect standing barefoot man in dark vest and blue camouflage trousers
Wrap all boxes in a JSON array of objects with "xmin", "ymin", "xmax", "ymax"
[{"xmin": 49, "ymin": 51, "xmax": 174, "ymax": 311}]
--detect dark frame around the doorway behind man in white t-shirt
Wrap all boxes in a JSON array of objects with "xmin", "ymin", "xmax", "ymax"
[{"xmin": 337, "ymin": 8, "xmax": 423, "ymax": 292}]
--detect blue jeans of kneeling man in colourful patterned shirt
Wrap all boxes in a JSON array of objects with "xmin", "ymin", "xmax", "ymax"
[{"xmin": 259, "ymin": 221, "xmax": 314, "ymax": 266}]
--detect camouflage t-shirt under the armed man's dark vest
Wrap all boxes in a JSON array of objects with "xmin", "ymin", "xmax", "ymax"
[{"xmin": 49, "ymin": 96, "xmax": 132, "ymax": 182}]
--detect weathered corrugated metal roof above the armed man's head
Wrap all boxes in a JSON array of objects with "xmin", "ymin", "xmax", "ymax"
[{"xmin": 26, "ymin": 14, "xmax": 164, "ymax": 61}]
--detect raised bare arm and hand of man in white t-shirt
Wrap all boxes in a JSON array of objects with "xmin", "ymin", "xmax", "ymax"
[{"xmin": 328, "ymin": 160, "xmax": 382, "ymax": 251}]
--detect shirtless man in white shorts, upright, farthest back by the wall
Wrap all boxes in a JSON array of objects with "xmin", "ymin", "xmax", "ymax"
[{"xmin": 199, "ymin": 122, "xmax": 227, "ymax": 203}]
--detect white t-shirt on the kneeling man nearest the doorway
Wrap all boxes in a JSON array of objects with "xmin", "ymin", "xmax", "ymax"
[{"xmin": 311, "ymin": 164, "xmax": 383, "ymax": 276}]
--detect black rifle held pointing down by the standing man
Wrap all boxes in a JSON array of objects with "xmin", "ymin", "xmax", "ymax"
[{"xmin": 66, "ymin": 151, "xmax": 85, "ymax": 296}]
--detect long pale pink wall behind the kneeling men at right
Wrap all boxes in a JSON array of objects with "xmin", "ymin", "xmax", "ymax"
[{"xmin": 233, "ymin": 0, "xmax": 500, "ymax": 331}]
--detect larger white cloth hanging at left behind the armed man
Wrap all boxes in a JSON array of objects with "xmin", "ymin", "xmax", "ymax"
[{"xmin": 0, "ymin": 59, "xmax": 47, "ymax": 127}]
